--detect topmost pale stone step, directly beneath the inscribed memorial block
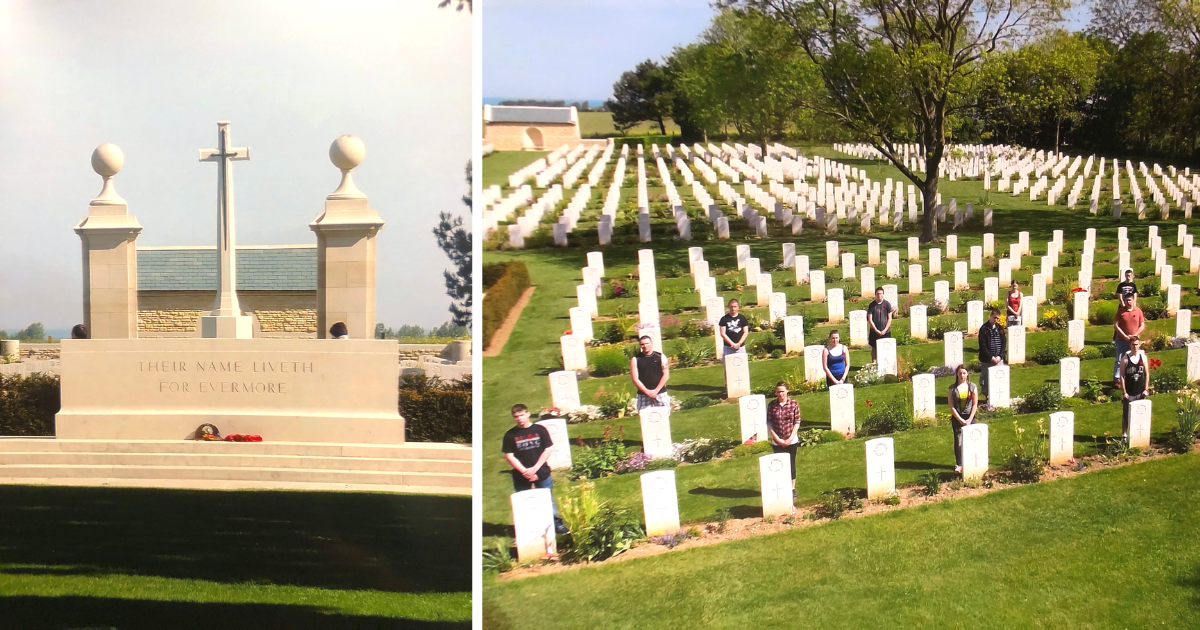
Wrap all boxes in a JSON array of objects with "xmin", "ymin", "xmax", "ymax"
[{"xmin": 0, "ymin": 437, "xmax": 472, "ymax": 462}]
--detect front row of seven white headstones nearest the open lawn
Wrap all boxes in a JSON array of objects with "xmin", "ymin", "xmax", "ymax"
[{"xmin": 510, "ymin": 400, "xmax": 1152, "ymax": 562}]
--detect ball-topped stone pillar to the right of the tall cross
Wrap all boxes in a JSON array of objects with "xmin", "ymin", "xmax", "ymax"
[{"xmin": 308, "ymin": 136, "xmax": 383, "ymax": 340}]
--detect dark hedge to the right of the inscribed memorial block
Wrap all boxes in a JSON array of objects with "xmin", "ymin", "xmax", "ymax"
[{"xmin": 400, "ymin": 374, "xmax": 470, "ymax": 444}]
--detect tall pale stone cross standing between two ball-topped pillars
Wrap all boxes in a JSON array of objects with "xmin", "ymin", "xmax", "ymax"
[{"xmin": 200, "ymin": 120, "xmax": 250, "ymax": 317}]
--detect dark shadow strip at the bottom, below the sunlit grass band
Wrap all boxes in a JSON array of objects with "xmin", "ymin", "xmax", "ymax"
[{"xmin": 0, "ymin": 595, "xmax": 470, "ymax": 630}]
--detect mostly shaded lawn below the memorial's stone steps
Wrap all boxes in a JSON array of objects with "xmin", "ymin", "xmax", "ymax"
[{"xmin": 0, "ymin": 486, "xmax": 472, "ymax": 628}]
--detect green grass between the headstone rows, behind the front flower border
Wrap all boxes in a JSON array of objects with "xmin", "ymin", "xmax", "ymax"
[{"xmin": 482, "ymin": 143, "xmax": 1200, "ymax": 538}]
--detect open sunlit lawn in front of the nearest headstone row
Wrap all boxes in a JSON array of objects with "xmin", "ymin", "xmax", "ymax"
[{"xmin": 484, "ymin": 454, "xmax": 1200, "ymax": 629}]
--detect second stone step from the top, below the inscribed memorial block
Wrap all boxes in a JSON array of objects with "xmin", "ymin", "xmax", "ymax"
[{"xmin": 0, "ymin": 451, "xmax": 470, "ymax": 474}]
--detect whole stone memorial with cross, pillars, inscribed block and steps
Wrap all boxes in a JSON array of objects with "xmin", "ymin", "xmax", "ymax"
[{"xmin": 0, "ymin": 121, "xmax": 468, "ymax": 494}]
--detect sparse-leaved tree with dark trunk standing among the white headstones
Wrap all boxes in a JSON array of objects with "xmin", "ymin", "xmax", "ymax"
[{"xmin": 726, "ymin": 0, "xmax": 1066, "ymax": 242}]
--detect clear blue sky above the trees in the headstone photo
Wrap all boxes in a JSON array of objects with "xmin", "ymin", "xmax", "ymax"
[{"xmin": 480, "ymin": 0, "xmax": 1088, "ymax": 101}]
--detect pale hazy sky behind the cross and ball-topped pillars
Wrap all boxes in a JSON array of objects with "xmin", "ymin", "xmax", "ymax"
[{"xmin": 0, "ymin": 0, "xmax": 478, "ymax": 330}]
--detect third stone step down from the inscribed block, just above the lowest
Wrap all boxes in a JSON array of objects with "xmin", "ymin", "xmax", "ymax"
[{"xmin": 0, "ymin": 463, "xmax": 472, "ymax": 493}]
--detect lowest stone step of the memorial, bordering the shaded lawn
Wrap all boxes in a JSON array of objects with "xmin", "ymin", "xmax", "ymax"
[{"xmin": 0, "ymin": 476, "xmax": 472, "ymax": 497}]
